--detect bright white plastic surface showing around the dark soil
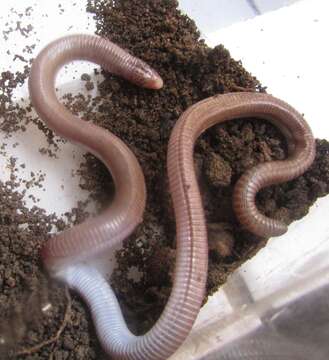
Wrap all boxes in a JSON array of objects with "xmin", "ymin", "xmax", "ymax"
[{"xmin": 0, "ymin": 0, "xmax": 329, "ymax": 360}]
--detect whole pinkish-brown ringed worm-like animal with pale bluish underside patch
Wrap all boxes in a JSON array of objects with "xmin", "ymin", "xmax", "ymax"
[{"xmin": 29, "ymin": 35, "xmax": 314, "ymax": 360}]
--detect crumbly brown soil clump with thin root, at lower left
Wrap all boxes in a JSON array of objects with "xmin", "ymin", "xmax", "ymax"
[{"xmin": 0, "ymin": 158, "xmax": 98, "ymax": 359}]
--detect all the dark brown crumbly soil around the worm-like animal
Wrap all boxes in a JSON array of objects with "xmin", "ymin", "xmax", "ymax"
[{"xmin": 0, "ymin": 0, "xmax": 329, "ymax": 360}]
